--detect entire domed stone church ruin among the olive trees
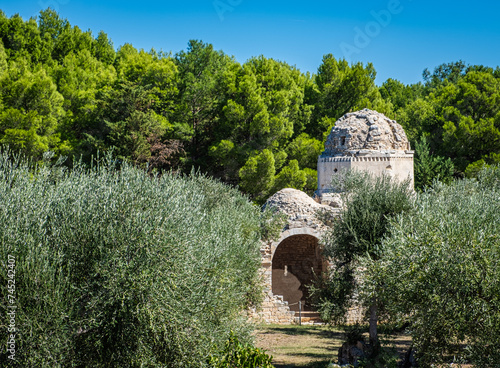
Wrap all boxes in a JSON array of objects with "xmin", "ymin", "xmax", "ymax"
[{"xmin": 254, "ymin": 109, "xmax": 414, "ymax": 323}]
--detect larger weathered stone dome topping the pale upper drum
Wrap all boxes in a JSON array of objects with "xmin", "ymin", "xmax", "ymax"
[{"xmin": 322, "ymin": 109, "xmax": 410, "ymax": 157}]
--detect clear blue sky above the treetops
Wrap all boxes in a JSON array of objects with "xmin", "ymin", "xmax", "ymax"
[{"xmin": 0, "ymin": 0, "xmax": 500, "ymax": 85}]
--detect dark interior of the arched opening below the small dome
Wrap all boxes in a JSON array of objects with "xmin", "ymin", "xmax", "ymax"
[{"xmin": 272, "ymin": 235, "xmax": 323, "ymax": 311}]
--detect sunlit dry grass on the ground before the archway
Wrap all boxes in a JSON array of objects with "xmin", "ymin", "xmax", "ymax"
[{"xmin": 255, "ymin": 325, "xmax": 410, "ymax": 368}]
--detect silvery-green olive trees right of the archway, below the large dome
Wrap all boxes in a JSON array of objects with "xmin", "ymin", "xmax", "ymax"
[{"xmin": 313, "ymin": 168, "xmax": 500, "ymax": 367}]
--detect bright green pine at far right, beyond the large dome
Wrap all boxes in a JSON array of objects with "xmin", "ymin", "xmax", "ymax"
[{"xmin": 390, "ymin": 61, "xmax": 500, "ymax": 178}]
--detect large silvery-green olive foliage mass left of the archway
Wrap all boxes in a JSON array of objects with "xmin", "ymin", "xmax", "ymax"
[{"xmin": 0, "ymin": 152, "xmax": 272, "ymax": 368}]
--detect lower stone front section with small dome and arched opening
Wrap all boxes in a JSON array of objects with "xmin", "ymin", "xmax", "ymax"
[{"xmin": 254, "ymin": 188, "xmax": 363, "ymax": 324}]
